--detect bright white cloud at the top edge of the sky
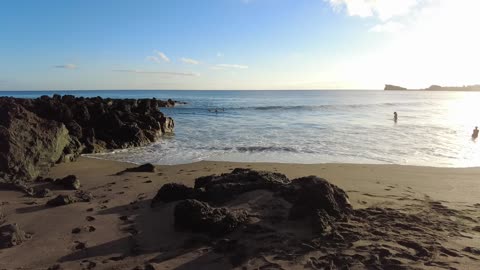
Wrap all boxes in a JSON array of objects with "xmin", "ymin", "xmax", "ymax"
[{"xmin": 324, "ymin": 0, "xmax": 425, "ymax": 21}]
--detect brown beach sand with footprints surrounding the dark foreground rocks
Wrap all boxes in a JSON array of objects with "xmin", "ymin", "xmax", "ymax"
[{"xmin": 0, "ymin": 158, "xmax": 480, "ymax": 269}]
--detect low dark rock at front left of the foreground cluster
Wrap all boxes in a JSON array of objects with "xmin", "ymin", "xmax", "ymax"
[{"xmin": 174, "ymin": 200, "xmax": 248, "ymax": 236}]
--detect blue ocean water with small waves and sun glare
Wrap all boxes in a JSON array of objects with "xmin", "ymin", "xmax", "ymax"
[{"xmin": 0, "ymin": 90, "xmax": 480, "ymax": 167}]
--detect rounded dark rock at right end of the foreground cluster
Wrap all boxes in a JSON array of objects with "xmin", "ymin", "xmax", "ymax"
[{"xmin": 282, "ymin": 176, "xmax": 352, "ymax": 219}]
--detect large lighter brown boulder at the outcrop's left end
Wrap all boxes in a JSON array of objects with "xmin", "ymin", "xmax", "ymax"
[{"xmin": 0, "ymin": 98, "xmax": 70, "ymax": 179}]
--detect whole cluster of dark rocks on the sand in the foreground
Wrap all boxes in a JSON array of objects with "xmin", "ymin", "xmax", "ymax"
[{"xmin": 152, "ymin": 169, "xmax": 352, "ymax": 236}]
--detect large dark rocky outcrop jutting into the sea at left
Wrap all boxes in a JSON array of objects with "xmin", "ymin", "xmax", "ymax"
[{"xmin": 0, "ymin": 95, "xmax": 176, "ymax": 180}]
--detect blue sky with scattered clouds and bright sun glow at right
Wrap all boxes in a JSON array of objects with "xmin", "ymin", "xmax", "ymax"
[{"xmin": 0, "ymin": 0, "xmax": 480, "ymax": 90}]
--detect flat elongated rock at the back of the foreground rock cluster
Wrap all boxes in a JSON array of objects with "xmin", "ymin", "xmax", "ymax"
[{"xmin": 195, "ymin": 168, "xmax": 290, "ymax": 202}]
